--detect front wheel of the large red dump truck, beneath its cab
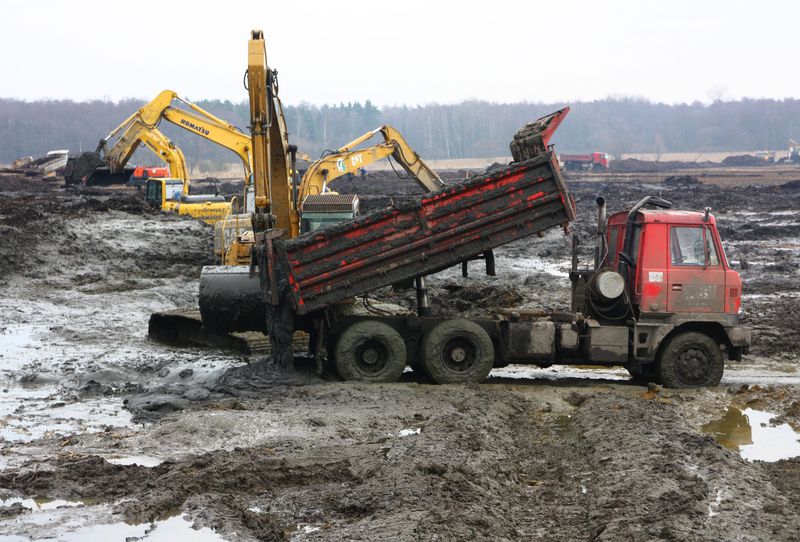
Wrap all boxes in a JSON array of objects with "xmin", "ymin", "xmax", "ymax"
[{"xmin": 657, "ymin": 331, "xmax": 725, "ymax": 388}]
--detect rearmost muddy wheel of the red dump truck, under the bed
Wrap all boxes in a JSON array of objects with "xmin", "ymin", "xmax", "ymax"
[{"xmin": 333, "ymin": 320, "xmax": 406, "ymax": 382}]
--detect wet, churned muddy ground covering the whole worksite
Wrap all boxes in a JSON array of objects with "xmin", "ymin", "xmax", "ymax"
[{"xmin": 0, "ymin": 167, "xmax": 800, "ymax": 540}]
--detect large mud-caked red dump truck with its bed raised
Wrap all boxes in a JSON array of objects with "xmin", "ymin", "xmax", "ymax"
[{"xmin": 201, "ymin": 111, "xmax": 750, "ymax": 387}]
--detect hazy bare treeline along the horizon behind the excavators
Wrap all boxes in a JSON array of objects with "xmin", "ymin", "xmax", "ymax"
[{"xmin": 0, "ymin": 99, "xmax": 800, "ymax": 171}]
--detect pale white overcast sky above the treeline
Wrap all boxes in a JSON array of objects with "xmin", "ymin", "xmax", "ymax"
[{"xmin": 0, "ymin": 0, "xmax": 800, "ymax": 105}]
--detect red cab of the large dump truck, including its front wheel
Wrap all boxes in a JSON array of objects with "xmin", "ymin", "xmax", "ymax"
[{"xmin": 579, "ymin": 204, "xmax": 750, "ymax": 387}]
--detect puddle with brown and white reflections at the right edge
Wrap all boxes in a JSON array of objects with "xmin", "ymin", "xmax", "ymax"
[{"xmin": 703, "ymin": 406, "xmax": 800, "ymax": 463}]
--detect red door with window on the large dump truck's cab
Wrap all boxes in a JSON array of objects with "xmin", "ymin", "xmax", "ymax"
[{"xmin": 667, "ymin": 226, "xmax": 725, "ymax": 312}]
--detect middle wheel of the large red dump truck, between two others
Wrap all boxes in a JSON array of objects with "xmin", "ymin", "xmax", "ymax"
[{"xmin": 422, "ymin": 319, "xmax": 494, "ymax": 384}]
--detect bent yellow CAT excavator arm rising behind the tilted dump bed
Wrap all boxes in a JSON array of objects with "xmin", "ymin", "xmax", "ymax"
[{"xmin": 298, "ymin": 125, "xmax": 444, "ymax": 202}]
